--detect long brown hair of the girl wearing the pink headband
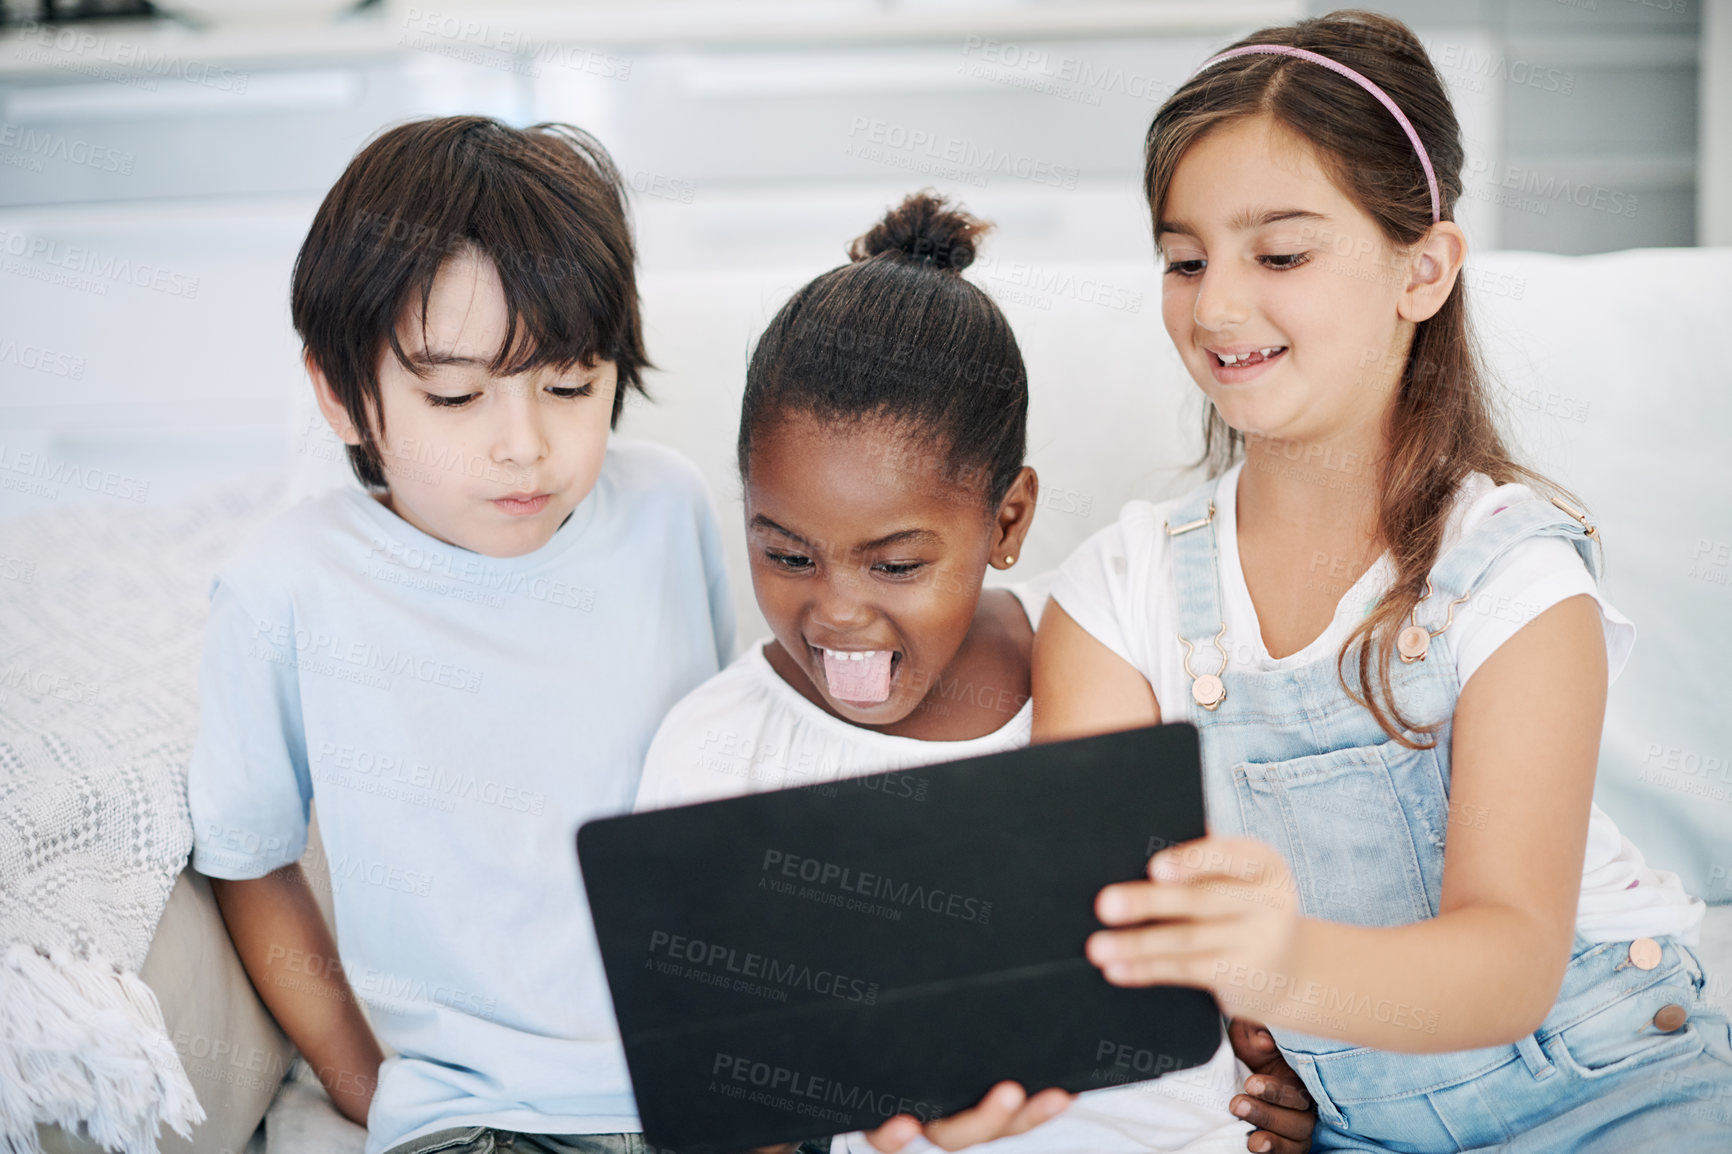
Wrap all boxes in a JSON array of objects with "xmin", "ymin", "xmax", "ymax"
[{"xmin": 1143, "ymin": 10, "xmax": 1562, "ymax": 749}]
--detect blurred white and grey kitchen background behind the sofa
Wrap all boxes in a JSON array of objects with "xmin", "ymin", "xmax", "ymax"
[{"xmin": 0, "ymin": 0, "xmax": 1729, "ymax": 523}]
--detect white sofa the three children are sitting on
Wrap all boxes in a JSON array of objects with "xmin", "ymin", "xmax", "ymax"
[{"xmin": 16, "ymin": 250, "xmax": 1732, "ymax": 1154}]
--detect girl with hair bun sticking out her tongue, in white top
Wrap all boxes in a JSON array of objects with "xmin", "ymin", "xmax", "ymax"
[{"xmin": 637, "ymin": 192, "xmax": 1313, "ymax": 1154}]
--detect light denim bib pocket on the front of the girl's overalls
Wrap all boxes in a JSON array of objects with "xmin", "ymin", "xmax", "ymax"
[{"xmin": 1233, "ymin": 742, "xmax": 1450, "ymax": 925}]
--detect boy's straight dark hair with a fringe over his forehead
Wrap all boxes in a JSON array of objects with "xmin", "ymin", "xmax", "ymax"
[{"xmin": 291, "ymin": 116, "xmax": 651, "ymax": 489}]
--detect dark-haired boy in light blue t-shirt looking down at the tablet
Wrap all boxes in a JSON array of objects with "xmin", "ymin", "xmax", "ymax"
[{"xmin": 189, "ymin": 116, "xmax": 733, "ymax": 1154}]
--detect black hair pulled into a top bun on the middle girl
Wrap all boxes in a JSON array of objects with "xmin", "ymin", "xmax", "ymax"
[{"xmin": 738, "ymin": 192, "xmax": 1029, "ymax": 509}]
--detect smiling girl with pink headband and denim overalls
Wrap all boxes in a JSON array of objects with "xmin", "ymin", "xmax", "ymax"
[{"xmin": 1034, "ymin": 12, "xmax": 1732, "ymax": 1154}]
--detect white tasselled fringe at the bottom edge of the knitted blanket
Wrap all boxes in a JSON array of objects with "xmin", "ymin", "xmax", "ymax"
[{"xmin": 0, "ymin": 943, "xmax": 204, "ymax": 1154}]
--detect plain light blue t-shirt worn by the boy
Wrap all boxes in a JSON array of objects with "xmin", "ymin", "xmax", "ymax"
[{"xmin": 189, "ymin": 440, "xmax": 733, "ymax": 1154}]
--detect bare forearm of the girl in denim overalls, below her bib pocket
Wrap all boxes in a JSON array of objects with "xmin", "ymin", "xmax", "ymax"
[{"xmin": 1218, "ymin": 906, "xmax": 1569, "ymax": 1054}]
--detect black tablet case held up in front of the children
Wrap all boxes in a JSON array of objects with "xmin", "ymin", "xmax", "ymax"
[{"xmin": 577, "ymin": 724, "xmax": 1225, "ymax": 1154}]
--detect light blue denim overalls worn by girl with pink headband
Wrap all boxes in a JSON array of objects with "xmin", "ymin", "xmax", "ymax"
[{"xmin": 1167, "ymin": 482, "xmax": 1732, "ymax": 1154}]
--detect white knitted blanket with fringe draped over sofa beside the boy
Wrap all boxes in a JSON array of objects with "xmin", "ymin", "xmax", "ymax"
[{"xmin": 0, "ymin": 482, "xmax": 281, "ymax": 1154}]
